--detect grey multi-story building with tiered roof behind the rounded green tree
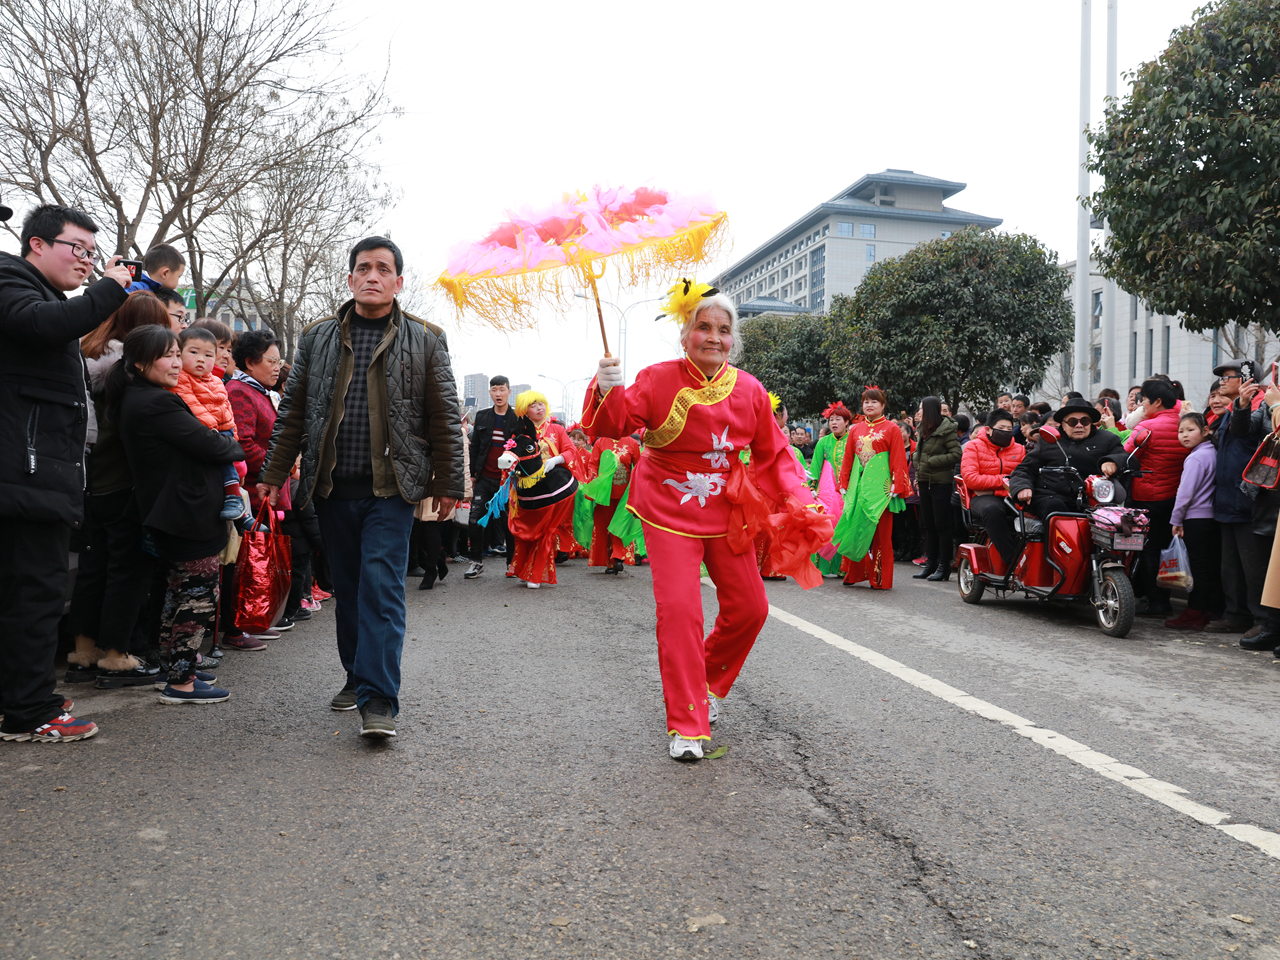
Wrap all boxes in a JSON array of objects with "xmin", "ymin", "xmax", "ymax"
[{"xmin": 712, "ymin": 170, "xmax": 1002, "ymax": 316}]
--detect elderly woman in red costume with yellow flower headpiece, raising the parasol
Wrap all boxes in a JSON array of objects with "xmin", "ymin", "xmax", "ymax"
[{"xmin": 582, "ymin": 280, "xmax": 831, "ymax": 760}]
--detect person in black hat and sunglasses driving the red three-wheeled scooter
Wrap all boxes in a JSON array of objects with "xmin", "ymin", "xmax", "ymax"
[{"xmin": 1009, "ymin": 399, "xmax": 1125, "ymax": 520}]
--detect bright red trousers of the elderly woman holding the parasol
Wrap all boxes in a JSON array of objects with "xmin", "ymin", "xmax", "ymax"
[{"xmin": 644, "ymin": 524, "xmax": 762, "ymax": 740}]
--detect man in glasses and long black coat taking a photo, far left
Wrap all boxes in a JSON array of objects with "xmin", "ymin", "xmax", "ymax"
[{"xmin": 0, "ymin": 205, "xmax": 129, "ymax": 742}]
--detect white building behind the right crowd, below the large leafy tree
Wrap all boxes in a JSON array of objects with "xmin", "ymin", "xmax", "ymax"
[{"xmin": 1041, "ymin": 260, "xmax": 1264, "ymax": 408}]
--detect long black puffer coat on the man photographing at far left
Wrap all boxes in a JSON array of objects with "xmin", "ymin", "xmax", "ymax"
[{"xmin": 0, "ymin": 253, "xmax": 127, "ymax": 526}]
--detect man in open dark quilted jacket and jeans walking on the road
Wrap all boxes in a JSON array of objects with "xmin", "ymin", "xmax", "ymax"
[{"xmin": 261, "ymin": 237, "xmax": 465, "ymax": 737}]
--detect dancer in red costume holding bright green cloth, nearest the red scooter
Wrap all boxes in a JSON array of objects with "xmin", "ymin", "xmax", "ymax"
[{"xmin": 837, "ymin": 387, "xmax": 911, "ymax": 590}]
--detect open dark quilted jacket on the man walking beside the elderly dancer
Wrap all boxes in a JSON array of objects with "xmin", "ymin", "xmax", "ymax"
[{"xmin": 261, "ymin": 300, "xmax": 466, "ymax": 509}]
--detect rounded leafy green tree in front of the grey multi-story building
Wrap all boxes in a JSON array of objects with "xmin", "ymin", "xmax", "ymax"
[{"xmin": 827, "ymin": 227, "xmax": 1073, "ymax": 412}]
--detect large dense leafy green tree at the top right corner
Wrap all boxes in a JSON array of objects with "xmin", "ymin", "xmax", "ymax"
[{"xmin": 1089, "ymin": 0, "xmax": 1280, "ymax": 330}]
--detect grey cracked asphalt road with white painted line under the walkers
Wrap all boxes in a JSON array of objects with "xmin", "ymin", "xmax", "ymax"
[{"xmin": 0, "ymin": 561, "xmax": 1280, "ymax": 960}]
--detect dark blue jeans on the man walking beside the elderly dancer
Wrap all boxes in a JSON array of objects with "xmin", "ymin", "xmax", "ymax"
[{"xmin": 315, "ymin": 497, "xmax": 413, "ymax": 713}]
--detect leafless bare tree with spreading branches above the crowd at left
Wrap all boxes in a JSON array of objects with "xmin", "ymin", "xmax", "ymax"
[{"xmin": 0, "ymin": 0, "xmax": 390, "ymax": 323}]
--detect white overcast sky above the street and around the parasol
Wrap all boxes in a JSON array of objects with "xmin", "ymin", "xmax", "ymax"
[{"xmin": 5, "ymin": 0, "xmax": 1198, "ymax": 407}]
